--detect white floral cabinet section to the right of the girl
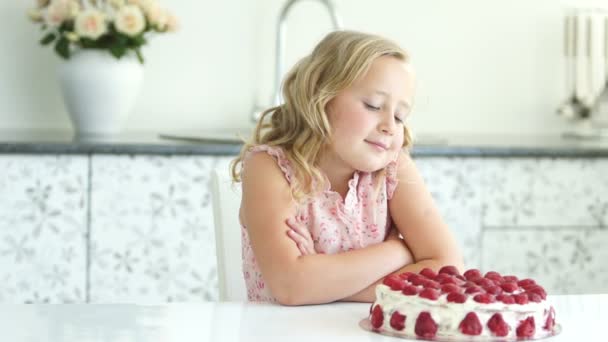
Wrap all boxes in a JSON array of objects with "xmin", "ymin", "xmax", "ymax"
[{"xmin": 417, "ymin": 157, "xmax": 608, "ymax": 294}]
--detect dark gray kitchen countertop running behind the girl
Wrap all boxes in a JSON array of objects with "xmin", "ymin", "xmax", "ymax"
[{"xmin": 0, "ymin": 131, "xmax": 608, "ymax": 157}]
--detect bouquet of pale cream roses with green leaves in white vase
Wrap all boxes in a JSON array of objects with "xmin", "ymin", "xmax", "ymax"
[{"xmin": 28, "ymin": 0, "xmax": 177, "ymax": 64}]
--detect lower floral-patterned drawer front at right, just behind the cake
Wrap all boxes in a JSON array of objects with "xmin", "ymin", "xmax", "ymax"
[{"xmin": 481, "ymin": 227, "xmax": 608, "ymax": 294}]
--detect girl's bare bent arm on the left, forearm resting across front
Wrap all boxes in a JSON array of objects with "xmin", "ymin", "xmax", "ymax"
[{"xmin": 241, "ymin": 153, "xmax": 411, "ymax": 305}]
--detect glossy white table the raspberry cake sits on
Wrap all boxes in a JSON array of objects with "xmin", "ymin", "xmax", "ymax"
[{"xmin": 0, "ymin": 294, "xmax": 608, "ymax": 342}]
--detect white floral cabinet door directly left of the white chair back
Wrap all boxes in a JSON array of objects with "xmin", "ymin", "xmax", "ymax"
[{"xmin": 91, "ymin": 155, "xmax": 230, "ymax": 302}]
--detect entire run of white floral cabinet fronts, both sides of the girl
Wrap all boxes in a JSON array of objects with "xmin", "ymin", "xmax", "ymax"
[{"xmin": 0, "ymin": 154, "xmax": 608, "ymax": 303}]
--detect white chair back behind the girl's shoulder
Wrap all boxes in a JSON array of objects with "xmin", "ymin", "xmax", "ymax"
[{"xmin": 211, "ymin": 169, "xmax": 247, "ymax": 301}]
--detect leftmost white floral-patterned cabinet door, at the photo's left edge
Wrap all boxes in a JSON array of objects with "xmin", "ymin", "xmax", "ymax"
[{"xmin": 0, "ymin": 155, "xmax": 88, "ymax": 303}]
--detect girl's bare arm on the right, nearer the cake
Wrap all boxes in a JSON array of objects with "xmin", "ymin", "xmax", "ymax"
[{"xmin": 389, "ymin": 152, "xmax": 464, "ymax": 272}]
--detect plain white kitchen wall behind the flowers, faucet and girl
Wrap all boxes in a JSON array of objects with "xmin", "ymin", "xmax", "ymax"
[{"xmin": 0, "ymin": 0, "xmax": 602, "ymax": 133}]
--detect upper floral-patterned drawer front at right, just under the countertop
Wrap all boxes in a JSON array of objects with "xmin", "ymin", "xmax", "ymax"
[{"xmin": 483, "ymin": 158, "xmax": 608, "ymax": 228}]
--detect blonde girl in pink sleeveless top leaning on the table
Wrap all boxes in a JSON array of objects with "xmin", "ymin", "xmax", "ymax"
[{"xmin": 232, "ymin": 31, "xmax": 462, "ymax": 305}]
